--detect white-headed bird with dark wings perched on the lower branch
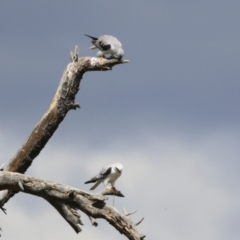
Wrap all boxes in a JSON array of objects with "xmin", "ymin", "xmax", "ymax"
[{"xmin": 85, "ymin": 163, "xmax": 123, "ymax": 190}]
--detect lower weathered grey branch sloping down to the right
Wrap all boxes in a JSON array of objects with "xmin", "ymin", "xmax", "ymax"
[{"xmin": 0, "ymin": 171, "xmax": 145, "ymax": 240}]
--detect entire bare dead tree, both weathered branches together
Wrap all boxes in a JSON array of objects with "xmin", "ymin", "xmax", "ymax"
[{"xmin": 0, "ymin": 47, "xmax": 145, "ymax": 240}]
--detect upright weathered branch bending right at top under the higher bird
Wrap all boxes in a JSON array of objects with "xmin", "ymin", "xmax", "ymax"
[{"xmin": 0, "ymin": 47, "xmax": 128, "ymax": 208}]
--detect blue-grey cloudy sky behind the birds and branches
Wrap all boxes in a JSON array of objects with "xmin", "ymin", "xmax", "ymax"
[{"xmin": 0, "ymin": 0, "xmax": 240, "ymax": 240}]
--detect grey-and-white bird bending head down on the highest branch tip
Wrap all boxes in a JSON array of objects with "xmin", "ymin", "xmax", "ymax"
[{"xmin": 84, "ymin": 34, "xmax": 124, "ymax": 59}]
